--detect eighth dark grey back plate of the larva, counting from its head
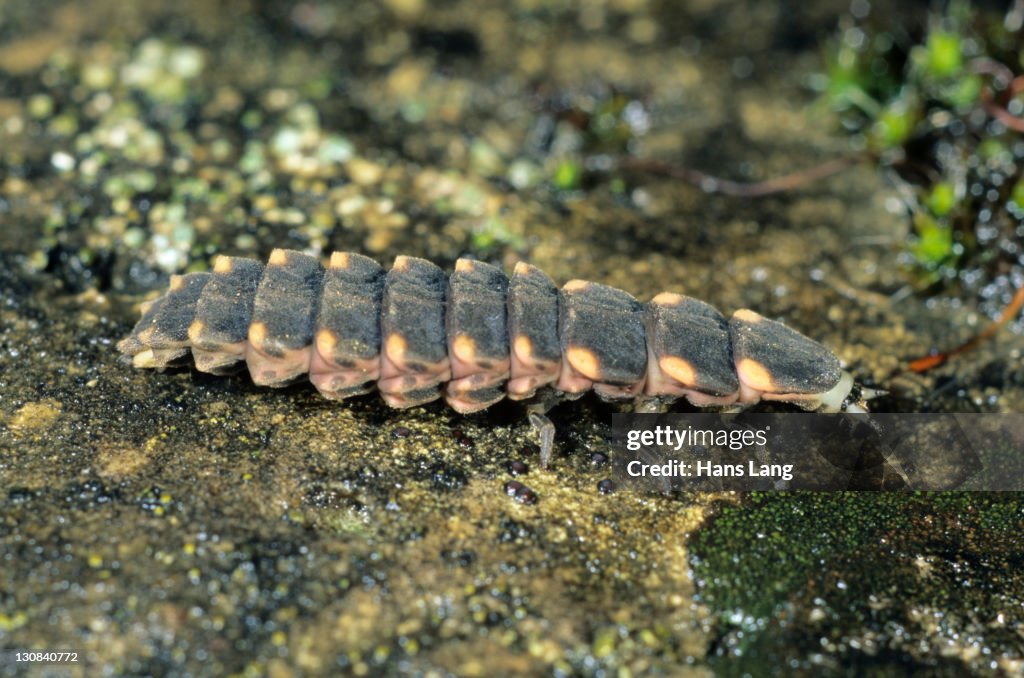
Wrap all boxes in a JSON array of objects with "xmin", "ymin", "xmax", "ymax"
[{"xmin": 252, "ymin": 250, "xmax": 324, "ymax": 357}]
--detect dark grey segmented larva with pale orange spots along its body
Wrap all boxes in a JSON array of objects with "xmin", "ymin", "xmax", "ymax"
[{"xmin": 118, "ymin": 250, "xmax": 854, "ymax": 464}]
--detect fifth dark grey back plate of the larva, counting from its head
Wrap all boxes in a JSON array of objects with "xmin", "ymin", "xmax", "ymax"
[{"xmin": 445, "ymin": 261, "xmax": 509, "ymax": 361}]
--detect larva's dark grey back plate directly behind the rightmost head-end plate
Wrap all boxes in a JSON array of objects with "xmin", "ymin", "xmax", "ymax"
[{"xmin": 646, "ymin": 296, "xmax": 739, "ymax": 395}]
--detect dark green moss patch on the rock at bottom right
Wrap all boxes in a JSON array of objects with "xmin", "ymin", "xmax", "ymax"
[{"xmin": 691, "ymin": 493, "xmax": 1024, "ymax": 661}]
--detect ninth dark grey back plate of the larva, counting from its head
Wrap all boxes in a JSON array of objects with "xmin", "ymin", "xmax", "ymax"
[{"xmin": 195, "ymin": 257, "xmax": 263, "ymax": 350}]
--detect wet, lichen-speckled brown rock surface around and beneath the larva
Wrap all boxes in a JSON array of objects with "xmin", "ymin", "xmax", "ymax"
[{"xmin": 0, "ymin": 0, "xmax": 1024, "ymax": 676}]
